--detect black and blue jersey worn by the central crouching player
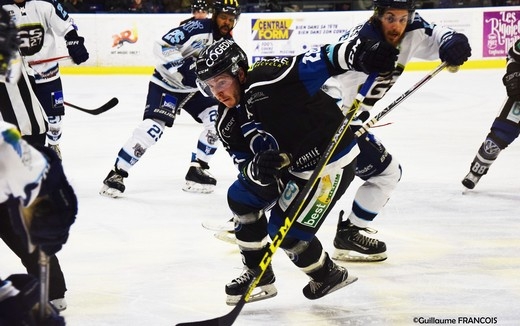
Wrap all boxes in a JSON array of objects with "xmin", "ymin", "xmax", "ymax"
[{"xmin": 217, "ymin": 45, "xmax": 359, "ymax": 178}]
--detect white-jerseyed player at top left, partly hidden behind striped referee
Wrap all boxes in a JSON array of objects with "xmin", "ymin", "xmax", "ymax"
[{"xmin": 2, "ymin": 0, "xmax": 89, "ymax": 157}]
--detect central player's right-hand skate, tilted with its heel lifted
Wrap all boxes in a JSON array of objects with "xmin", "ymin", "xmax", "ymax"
[{"xmin": 303, "ymin": 260, "xmax": 358, "ymax": 300}]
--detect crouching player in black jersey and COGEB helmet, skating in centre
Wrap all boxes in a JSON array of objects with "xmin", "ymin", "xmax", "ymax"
[{"xmin": 197, "ymin": 39, "xmax": 398, "ymax": 305}]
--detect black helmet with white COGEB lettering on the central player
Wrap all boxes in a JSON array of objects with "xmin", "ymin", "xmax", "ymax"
[{"xmin": 196, "ymin": 39, "xmax": 249, "ymax": 81}]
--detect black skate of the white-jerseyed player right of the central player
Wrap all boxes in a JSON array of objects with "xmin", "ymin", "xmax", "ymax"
[{"xmin": 332, "ymin": 211, "xmax": 387, "ymax": 262}]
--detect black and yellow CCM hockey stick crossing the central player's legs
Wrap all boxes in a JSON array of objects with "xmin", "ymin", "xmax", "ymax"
[{"xmin": 177, "ymin": 73, "xmax": 377, "ymax": 326}]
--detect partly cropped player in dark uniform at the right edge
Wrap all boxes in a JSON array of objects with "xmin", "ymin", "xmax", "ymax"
[{"xmin": 462, "ymin": 40, "xmax": 520, "ymax": 189}]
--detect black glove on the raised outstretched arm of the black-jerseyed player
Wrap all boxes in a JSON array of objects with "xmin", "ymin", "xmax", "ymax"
[{"xmin": 354, "ymin": 40, "xmax": 399, "ymax": 74}]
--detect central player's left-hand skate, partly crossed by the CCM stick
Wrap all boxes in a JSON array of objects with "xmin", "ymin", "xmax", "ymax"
[{"xmin": 226, "ymin": 265, "xmax": 278, "ymax": 306}]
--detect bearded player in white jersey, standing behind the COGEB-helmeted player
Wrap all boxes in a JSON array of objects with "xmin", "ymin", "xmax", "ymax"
[{"xmin": 100, "ymin": 0, "xmax": 240, "ymax": 197}]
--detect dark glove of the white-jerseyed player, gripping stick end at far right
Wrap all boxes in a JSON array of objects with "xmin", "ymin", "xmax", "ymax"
[{"xmin": 439, "ymin": 33, "xmax": 471, "ymax": 66}]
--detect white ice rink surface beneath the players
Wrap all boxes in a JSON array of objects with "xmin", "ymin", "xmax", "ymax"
[{"xmin": 0, "ymin": 69, "xmax": 520, "ymax": 326}]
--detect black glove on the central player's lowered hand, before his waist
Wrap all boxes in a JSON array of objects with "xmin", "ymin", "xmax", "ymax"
[{"xmin": 249, "ymin": 149, "xmax": 292, "ymax": 184}]
